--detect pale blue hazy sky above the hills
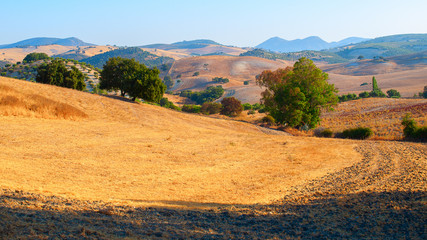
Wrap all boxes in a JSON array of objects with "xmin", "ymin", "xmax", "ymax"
[{"xmin": 0, "ymin": 0, "xmax": 427, "ymax": 47}]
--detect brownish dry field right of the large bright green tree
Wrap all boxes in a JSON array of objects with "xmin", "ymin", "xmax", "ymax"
[{"xmin": 320, "ymin": 98, "xmax": 427, "ymax": 140}]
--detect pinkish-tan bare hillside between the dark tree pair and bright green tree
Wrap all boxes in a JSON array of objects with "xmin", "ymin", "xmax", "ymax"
[{"xmin": 169, "ymin": 56, "xmax": 288, "ymax": 103}]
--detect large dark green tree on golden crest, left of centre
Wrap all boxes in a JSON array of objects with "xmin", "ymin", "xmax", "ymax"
[{"xmin": 99, "ymin": 57, "xmax": 166, "ymax": 102}]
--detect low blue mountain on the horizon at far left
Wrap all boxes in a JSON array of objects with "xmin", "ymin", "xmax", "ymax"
[{"xmin": 0, "ymin": 37, "xmax": 95, "ymax": 49}]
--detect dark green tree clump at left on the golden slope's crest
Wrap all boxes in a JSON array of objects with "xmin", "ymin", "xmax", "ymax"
[{"xmin": 36, "ymin": 60, "xmax": 86, "ymax": 91}]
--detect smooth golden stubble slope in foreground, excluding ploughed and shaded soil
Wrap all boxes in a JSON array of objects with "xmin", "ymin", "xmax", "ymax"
[{"xmin": 0, "ymin": 78, "xmax": 361, "ymax": 207}]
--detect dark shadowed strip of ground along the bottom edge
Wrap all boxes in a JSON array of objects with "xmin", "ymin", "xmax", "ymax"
[{"xmin": 0, "ymin": 190, "xmax": 427, "ymax": 239}]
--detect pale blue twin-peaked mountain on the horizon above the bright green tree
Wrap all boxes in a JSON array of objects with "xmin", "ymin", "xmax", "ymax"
[{"xmin": 256, "ymin": 36, "xmax": 367, "ymax": 53}]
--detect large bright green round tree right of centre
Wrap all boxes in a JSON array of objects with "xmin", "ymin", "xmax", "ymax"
[{"xmin": 257, "ymin": 58, "xmax": 338, "ymax": 128}]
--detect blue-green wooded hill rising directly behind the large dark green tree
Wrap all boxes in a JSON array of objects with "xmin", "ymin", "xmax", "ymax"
[{"xmin": 80, "ymin": 47, "xmax": 174, "ymax": 68}]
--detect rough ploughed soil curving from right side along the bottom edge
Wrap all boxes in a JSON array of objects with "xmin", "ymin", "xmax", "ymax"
[{"xmin": 0, "ymin": 141, "xmax": 427, "ymax": 239}]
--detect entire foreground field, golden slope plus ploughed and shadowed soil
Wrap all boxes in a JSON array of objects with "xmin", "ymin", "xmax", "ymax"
[{"xmin": 0, "ymin": 77, "xmax": 427, "ymax": 239}]
